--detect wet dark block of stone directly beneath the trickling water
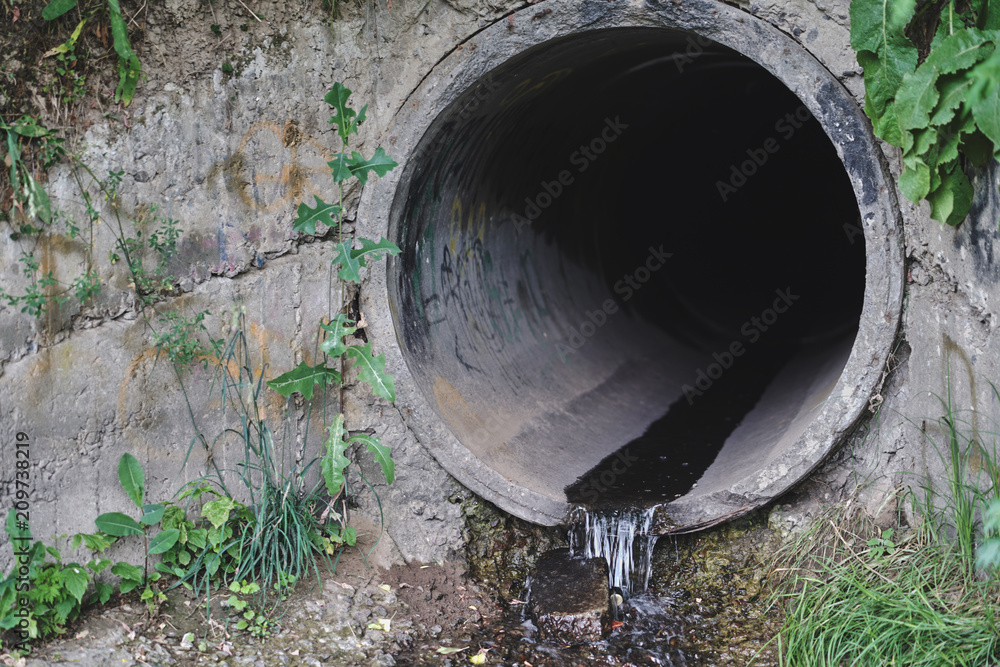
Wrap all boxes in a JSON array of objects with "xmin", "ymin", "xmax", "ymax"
[{"xmin": 531, "ymin": 549, "xmax": 610, "ymax": 641}]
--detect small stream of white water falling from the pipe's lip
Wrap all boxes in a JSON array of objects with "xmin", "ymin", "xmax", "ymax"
[{"xmin": 570, "ymin": 508, "xmax": 658, "ymax": 599}]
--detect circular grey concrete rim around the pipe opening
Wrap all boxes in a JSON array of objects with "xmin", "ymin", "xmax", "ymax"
[{"xmin": 356, "ymin": 0, "xmax": 905, "ymax": 533}]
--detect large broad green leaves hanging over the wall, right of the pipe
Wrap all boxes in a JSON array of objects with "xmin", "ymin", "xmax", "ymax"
[{"xmin": 851, "ymin": 0, "xmax": 1000, "ymax": 225}]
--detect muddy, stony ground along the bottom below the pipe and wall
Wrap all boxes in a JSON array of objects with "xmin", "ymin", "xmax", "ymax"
[{"xmin": 5, "ymin": 510, "xmax": 780, "ymax": 667}]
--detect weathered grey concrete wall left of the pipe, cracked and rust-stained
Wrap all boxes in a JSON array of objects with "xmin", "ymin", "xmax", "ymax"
[{"xmin": 0, "ymin": 0, "xmax": 520, "ymax": 563}]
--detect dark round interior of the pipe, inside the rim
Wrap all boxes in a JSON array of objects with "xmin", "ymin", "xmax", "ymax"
[{"xmin": 389, "ymin": 28, "xmax": 866, "ymax": 506}]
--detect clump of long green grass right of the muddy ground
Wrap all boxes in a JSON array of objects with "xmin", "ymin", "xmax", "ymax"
[{"xmin": 776, "ymin": 378, "xmax": 1000, "ymax": 667}]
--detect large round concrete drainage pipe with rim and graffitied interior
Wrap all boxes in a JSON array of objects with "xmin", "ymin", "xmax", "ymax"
[{"xmin": 361, "ymin": 1, "xmax": 903, "ymax": 532}]
